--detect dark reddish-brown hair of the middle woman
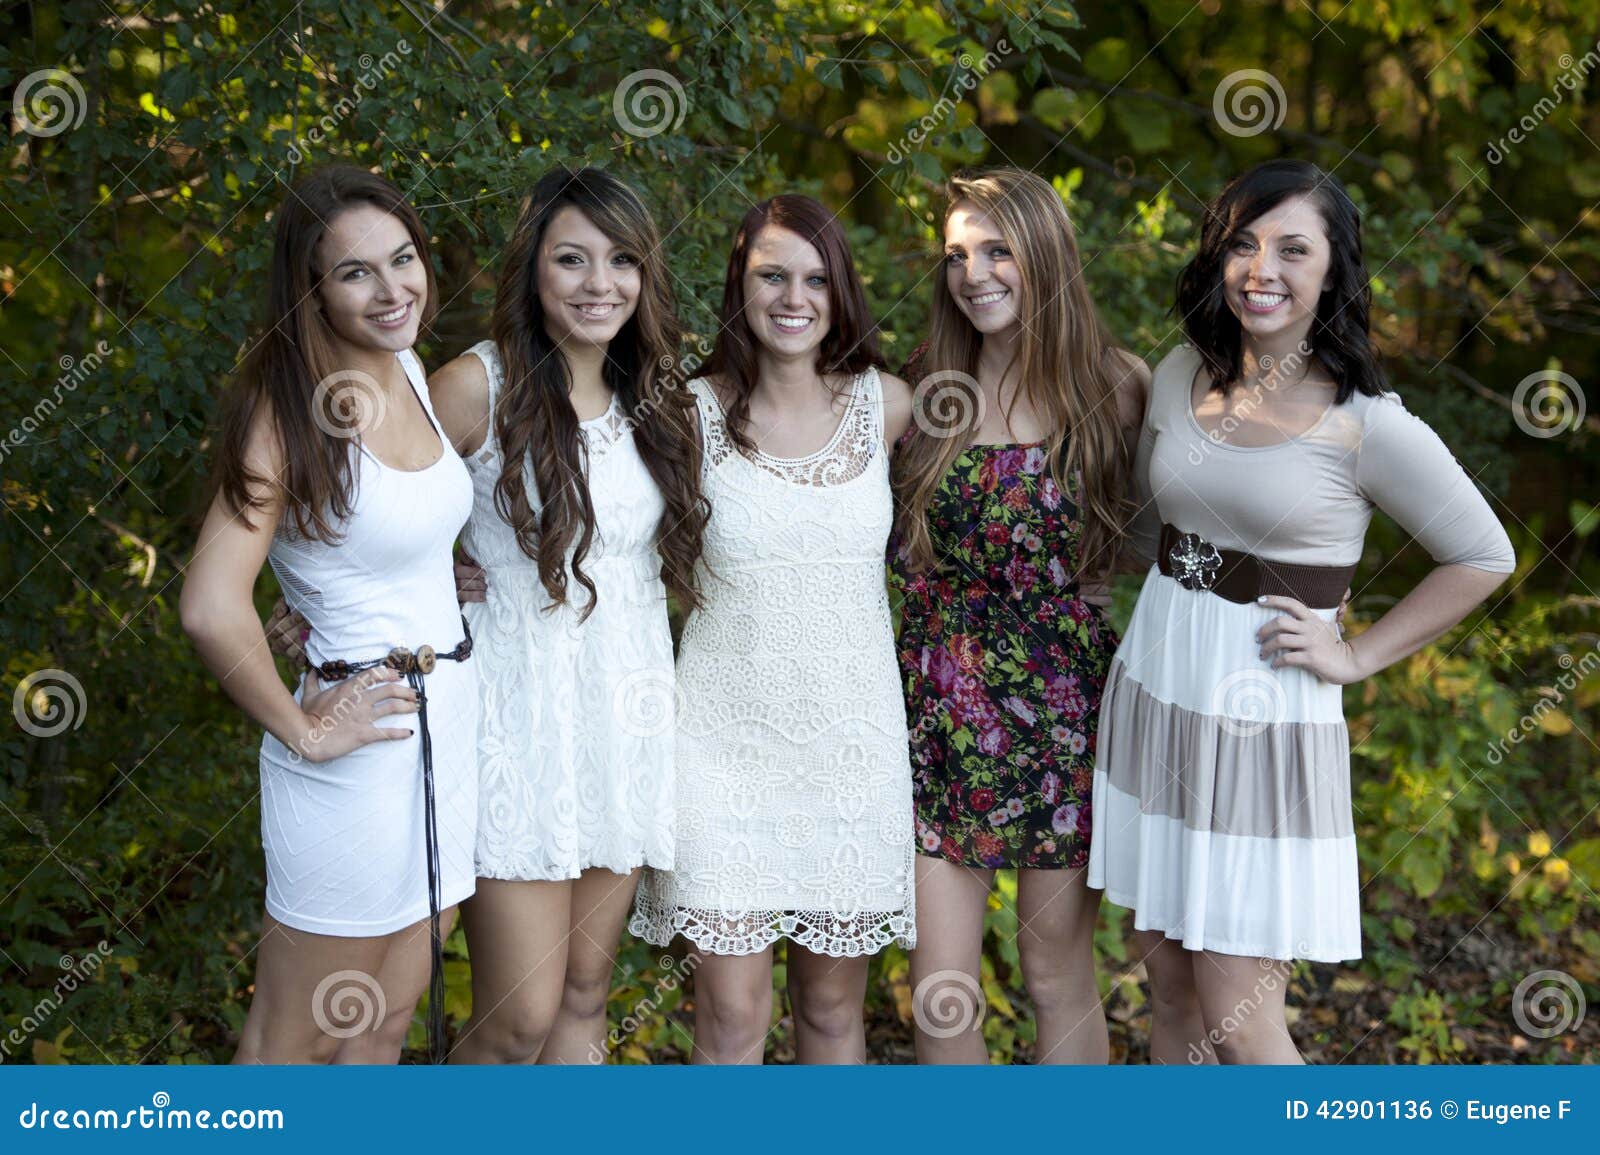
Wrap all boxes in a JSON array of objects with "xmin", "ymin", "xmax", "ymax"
[{"xmin": 702, "ymin": 194, "xmax": 883, "ymax": 451}]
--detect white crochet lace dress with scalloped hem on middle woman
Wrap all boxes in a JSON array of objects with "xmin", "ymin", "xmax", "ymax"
[{"xmin": 629, "ymin": 370, "xmax": 915, "ymax": 957}]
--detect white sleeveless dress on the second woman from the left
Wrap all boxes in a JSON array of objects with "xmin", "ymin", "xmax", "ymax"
[{"xmin": 462, "ymin": 341, "xmax": 674, "ymax": 880}]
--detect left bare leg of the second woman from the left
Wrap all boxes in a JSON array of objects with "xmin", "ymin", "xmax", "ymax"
[{"xmin": 450, "ymin": 878, "xmax": 573, "ymax": 1062}]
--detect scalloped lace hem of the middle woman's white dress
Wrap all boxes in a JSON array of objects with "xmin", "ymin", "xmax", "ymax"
[{"xmin": 627, "ymin": 902, "xmax": 917, "ymax": 958}]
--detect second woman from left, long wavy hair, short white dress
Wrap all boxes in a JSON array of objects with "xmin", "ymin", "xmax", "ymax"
[{"xmin": 434, "ymin": 170, "xmax": 706, "ymax": 1062}]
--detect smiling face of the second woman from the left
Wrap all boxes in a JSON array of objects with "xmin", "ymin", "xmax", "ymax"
[{"xmin": 536, "ymin": 205, "xmax": 642, "ymax": 347}]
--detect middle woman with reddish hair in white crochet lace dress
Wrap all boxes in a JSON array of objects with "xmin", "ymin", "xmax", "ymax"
[{"xmin": 630, "ymin": 197, "xmax": 915, "ymax": 1062}]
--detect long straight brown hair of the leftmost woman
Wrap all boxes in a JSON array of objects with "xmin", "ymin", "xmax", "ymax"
[{"xmin": 216, "ymin": 165, "xmax": 438, "ymax": 544}]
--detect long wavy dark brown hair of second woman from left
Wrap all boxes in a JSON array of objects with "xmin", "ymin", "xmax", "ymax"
[{"xmin": 491, "ymin": 168, "xmax": 709, "ymax": 617}]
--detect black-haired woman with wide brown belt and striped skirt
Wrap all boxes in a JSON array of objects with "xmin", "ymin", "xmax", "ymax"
[{"xmin": 1090, "ymin": 160, "xmax": 1514, "ymax": 1062}]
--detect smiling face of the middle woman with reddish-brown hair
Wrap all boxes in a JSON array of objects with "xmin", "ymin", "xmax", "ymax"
[{"xmin": 744, "ymin": 224, "xmax": 834, "ymax": 357}]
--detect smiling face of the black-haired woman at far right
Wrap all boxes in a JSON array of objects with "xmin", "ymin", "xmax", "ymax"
[{"xmin": 1222, "ymin": 197, "xmax": 1333, "ymax": 342}]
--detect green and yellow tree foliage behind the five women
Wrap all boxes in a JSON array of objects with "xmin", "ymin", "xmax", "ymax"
[{"xmin": 0, "ymin": 0, "xmax": 1600, "ymax": 1062}]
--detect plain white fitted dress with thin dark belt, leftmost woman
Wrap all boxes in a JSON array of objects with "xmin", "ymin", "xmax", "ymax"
[{"xmin": 261, "ymin": 350, "xmax": 478, "ymax": 937}]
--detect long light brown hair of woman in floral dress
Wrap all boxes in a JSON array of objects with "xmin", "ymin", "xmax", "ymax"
[{"xmin": 894, "ymin": 168, "xmax": 1130, "ymax": 578}]
